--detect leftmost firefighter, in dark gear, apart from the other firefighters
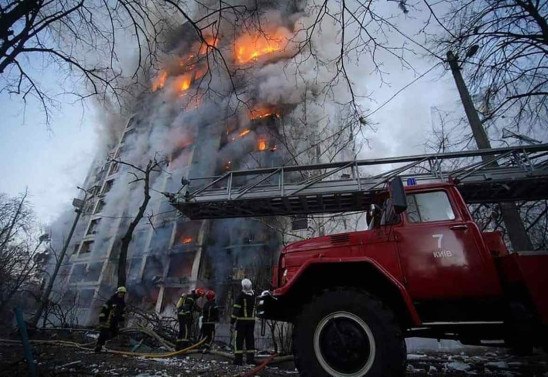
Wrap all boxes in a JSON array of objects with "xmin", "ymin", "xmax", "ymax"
[{"xmin": 95, "ymin": 287, "xmax": 127, "ymax": 352}]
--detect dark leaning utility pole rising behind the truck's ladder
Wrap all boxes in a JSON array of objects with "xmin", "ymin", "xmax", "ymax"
[{"xmin": 447, "ymin": 51, "xmax": 533, "ymax": 250}]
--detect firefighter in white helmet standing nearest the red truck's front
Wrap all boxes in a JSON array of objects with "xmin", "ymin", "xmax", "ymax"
[{"xmin": 230, "ymin": 278, "xmax": 255, "ymax": 365}]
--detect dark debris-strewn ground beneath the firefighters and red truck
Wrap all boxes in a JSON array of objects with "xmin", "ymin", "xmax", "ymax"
[{"xmin": 0, "ymin": 328, "xmax": 548, "ymax": 377}]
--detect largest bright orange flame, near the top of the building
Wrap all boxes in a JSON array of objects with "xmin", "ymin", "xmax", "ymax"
[{"xmin": 234, "ymin": 32, "xmax": 287, "ymax": 64}]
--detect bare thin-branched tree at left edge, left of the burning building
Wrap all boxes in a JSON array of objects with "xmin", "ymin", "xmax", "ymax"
[{"xmin": 0, "ymin": 192, "xmax": 47, "ymax": 312}]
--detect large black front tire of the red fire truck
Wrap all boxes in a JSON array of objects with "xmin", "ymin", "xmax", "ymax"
[{"xmin": 293, "ymin": 287, "xmax": 406, "ymax": 377}]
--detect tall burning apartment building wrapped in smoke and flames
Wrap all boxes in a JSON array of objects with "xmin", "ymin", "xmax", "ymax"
[{"xmin": 48, "ymin": 2, "xmax": 356, "ymax": 325}]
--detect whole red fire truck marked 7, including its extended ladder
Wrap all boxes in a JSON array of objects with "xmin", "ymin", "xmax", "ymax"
[{"xmin": 169, "ymin": 145, "xmax": 548, "ymax": 377}]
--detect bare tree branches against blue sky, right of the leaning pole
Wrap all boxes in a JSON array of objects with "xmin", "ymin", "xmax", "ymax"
[{"xmin": 430, "ymin": 0, "xmax": 548, "ymax": 133}]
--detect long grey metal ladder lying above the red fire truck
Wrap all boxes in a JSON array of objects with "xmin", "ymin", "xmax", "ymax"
[{"xmin": 167, "ymin": 144, "xmax": 548, "ymax": 219}]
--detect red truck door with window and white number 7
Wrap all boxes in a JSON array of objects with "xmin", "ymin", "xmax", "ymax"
[{"xmin": 394, "ymin": 189, "xmax": 500, "ymax": 300}]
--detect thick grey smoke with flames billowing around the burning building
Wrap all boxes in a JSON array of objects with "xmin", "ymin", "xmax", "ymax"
[{"xmin": 53, "ymin": 1, "xmax": 366, "ymax": 320}]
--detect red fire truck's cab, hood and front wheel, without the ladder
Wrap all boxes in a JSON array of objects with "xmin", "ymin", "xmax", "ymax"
[{"xmin": 259, "ymin": 178, "xmax": 548, "ymax": 377}]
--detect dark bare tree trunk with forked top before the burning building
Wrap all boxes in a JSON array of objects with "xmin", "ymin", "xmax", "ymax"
[{"xmin": 110, "ymin": 158, "xmax": 166, "ymax": 286}]
